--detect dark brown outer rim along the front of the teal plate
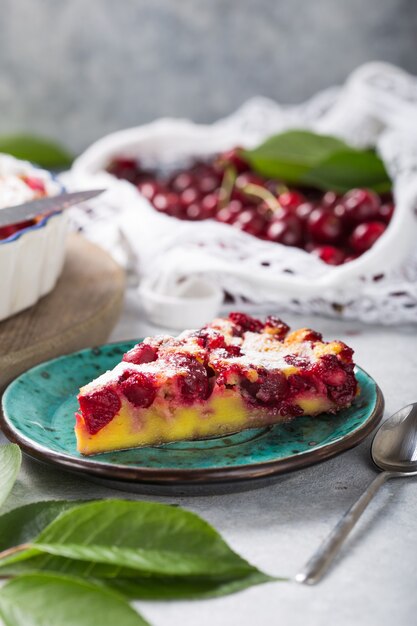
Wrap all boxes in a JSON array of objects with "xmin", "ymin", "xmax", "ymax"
[{"xmin": 0, "ymin": 368, "xmax": 385, "ymax": 486}]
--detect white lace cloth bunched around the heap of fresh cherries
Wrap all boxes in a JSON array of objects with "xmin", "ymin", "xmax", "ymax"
[{"xmin": 64, "ymin": 63, "xmax": 417, "ymax": 328}]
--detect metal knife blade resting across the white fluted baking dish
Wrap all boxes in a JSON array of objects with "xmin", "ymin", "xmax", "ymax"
[{"xmin": 0, "ymin": 189, "xmax": 105, "ymax": 227}]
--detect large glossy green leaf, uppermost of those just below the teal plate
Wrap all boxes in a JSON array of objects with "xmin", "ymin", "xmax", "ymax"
[{"xmin": 0, "ymin": 500, "xmax": 257, "ymax": 579}]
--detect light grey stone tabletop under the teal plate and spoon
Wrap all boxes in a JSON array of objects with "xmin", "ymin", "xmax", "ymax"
[{"xmin": 0, "ymin": 297, "xmax": 417, "ymax": 626}]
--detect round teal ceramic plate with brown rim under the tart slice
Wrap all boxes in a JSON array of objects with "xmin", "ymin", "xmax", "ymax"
[{"xmin": 1, "ymin": 342, "xmax": 383, "ymax": 487}]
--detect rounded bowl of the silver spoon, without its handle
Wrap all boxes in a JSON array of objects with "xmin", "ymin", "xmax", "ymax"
[{"xmin": 371, "ymin": 403, "xmax": 417, "ymax": 474}]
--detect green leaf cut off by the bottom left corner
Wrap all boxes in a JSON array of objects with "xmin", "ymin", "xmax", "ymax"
[{"xmin": 0, "ymin": 574, "xmax": 148, "ymax": 626}]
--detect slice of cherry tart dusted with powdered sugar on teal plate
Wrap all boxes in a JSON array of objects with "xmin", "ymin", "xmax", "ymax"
[{"xmin": 75, "ymin": 313, "xmax": 358, "ymax": 454}]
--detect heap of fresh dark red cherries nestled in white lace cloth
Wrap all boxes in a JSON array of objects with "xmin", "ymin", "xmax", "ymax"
[{"xmin": 106, "ymin": 147, "xmax": 395, "ymax": 265}]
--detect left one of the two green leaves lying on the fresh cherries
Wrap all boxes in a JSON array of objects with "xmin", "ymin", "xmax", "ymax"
[{"xmin": 244, "ymin": 130, "xmax": 347, "ymax": 183}]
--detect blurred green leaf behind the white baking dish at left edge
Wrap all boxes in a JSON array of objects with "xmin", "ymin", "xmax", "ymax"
[{"xmin": 0, "ymin": 134, "xmax": 73, "ymax": 169}]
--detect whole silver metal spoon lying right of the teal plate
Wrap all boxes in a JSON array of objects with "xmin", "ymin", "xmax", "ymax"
[{"xmin": 295, "ymin": 403, "xmax": 417, "ymax": 585}]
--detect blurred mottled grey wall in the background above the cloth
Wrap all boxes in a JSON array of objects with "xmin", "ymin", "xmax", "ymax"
[{"xmin": 0, "ymin": 0, "xmax": 417, "ymax": 151}]
